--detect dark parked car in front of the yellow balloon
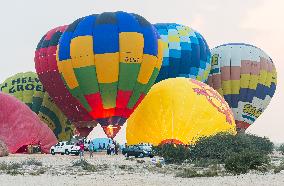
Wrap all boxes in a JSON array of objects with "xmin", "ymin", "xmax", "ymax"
[{"xmin": 122, "ymin": 145, "xmax": 154, "ymax": 158}]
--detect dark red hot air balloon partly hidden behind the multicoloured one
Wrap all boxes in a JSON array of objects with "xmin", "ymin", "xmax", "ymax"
[{"xmin": 34, "ymin": 26, "xmax": 97, "ymax": 136}]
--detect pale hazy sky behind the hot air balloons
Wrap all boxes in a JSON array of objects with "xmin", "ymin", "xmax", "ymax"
[{"xmin": 0, "ymin": 0, "xmax": 284, "ymax": 143}]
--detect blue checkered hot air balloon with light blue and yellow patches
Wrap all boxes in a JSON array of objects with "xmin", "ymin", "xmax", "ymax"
[{"xmin": 154, "ymin": 23, "xmax": 211, "ymax": 82}]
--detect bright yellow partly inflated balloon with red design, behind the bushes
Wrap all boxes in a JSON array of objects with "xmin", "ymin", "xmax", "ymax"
[{"xmin": 126, "ymin": 78, "xmax": 236, "ymax": 145}]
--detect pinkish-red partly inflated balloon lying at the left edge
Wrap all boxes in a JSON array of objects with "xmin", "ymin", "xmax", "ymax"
[{"xmin": 0, "ymin": 92, "xmax": 57, "ymax": 153}]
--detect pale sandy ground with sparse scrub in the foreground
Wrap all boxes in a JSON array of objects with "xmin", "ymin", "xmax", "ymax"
[{"xmin": 0, "ymin": 154, "xmax": 284, "ymax": 186}]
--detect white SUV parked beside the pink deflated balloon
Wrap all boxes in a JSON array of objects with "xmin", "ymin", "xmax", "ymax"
[{"xmin": 50, "ymin": 141, "xmax": 80, "ymax": 156}]
